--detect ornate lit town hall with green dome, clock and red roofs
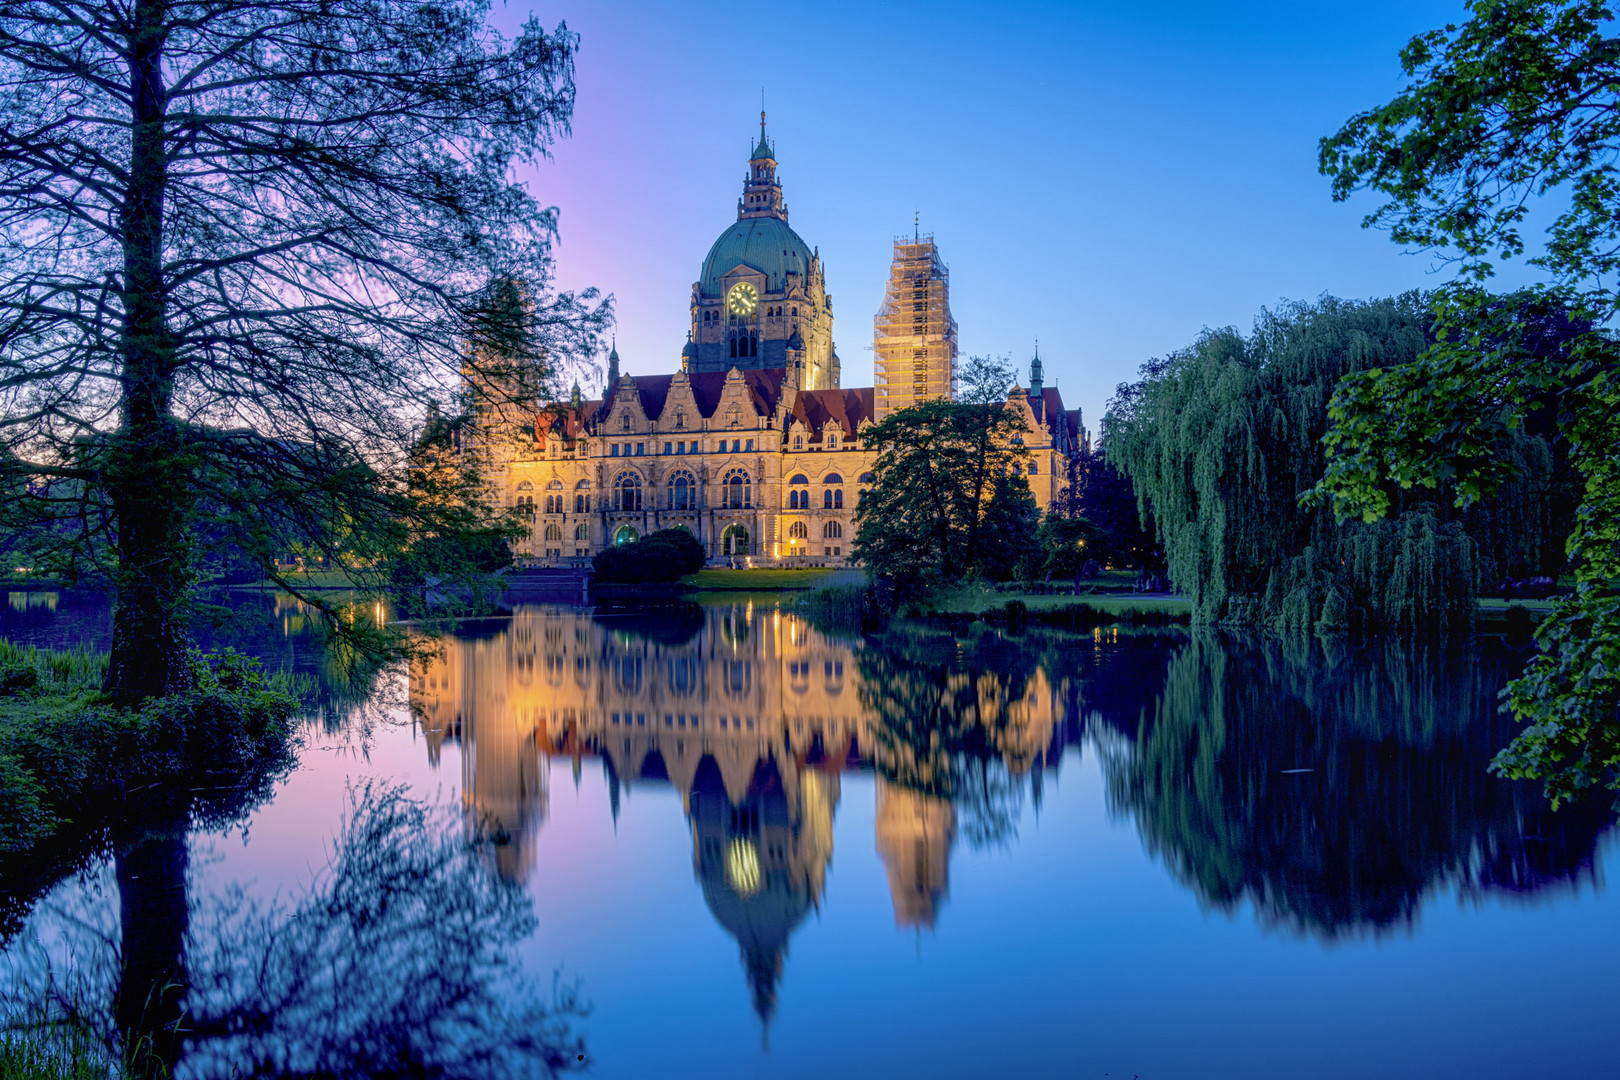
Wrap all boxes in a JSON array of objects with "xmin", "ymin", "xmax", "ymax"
[{"xmin": 475, "ymin": 113, "xmax": 1085, "ymax": 565}]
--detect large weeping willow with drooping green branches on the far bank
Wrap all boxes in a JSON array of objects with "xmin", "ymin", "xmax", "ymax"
[{"xmin": 1105, "ymin": 293, "xmax": 1562, "ymax": 631}]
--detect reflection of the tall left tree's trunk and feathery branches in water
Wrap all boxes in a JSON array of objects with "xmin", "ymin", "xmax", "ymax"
[{"xmin": 8, "ymin": 784, "xmax": 586, "ymax": 1078}]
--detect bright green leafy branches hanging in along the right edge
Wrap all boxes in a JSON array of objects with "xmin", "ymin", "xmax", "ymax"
[{"xmin": 1320, "ymin": 0, "xmax": 1620, "ymax": 805}]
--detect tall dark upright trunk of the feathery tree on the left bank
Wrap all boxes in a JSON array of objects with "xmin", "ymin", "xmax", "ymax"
[{"xmin": 104, "ymin": 0, "xmax": 193, "ymax": 706}]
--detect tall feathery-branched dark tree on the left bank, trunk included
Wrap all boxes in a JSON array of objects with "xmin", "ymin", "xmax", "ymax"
[{"xmin": 0, "ymin": 0, "xmax": 608, "ymax": 704}]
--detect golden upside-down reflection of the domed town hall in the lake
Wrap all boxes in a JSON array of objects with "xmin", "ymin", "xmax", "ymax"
[{"xmin": 410, "ymin": 604, "xmax": 1066, "ymax": 1018}]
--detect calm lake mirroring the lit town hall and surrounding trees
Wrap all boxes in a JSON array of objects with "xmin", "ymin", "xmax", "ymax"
[{"xmin": 0, "ymin": 593, "xmax": 1620, "ymax": 1080}]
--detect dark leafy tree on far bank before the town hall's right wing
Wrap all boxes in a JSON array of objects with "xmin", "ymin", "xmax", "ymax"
[{"xmin": 852, "ymin": 358, "xmax": 1040, "ymax": 591}]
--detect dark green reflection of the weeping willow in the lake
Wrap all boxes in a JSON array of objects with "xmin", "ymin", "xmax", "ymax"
[{"xmin": 1105, "ymin": 633, "xmax": 1614, "ymax": 939}]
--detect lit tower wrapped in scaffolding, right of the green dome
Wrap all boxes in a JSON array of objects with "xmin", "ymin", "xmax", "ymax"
[{"xmin": 873, "ymin": 233, "xmax": 956, "ymax": 419}]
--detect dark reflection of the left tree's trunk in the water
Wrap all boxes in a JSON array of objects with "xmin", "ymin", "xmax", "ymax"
[{"xmin": 117, "ymin": 821, "xmax": 190, "ymax": 1080}]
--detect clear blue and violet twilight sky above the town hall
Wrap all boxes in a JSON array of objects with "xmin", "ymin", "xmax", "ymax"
[{"xmin": 494, "ymin": 0, "xmax": 1483, "ymax": 431}]
